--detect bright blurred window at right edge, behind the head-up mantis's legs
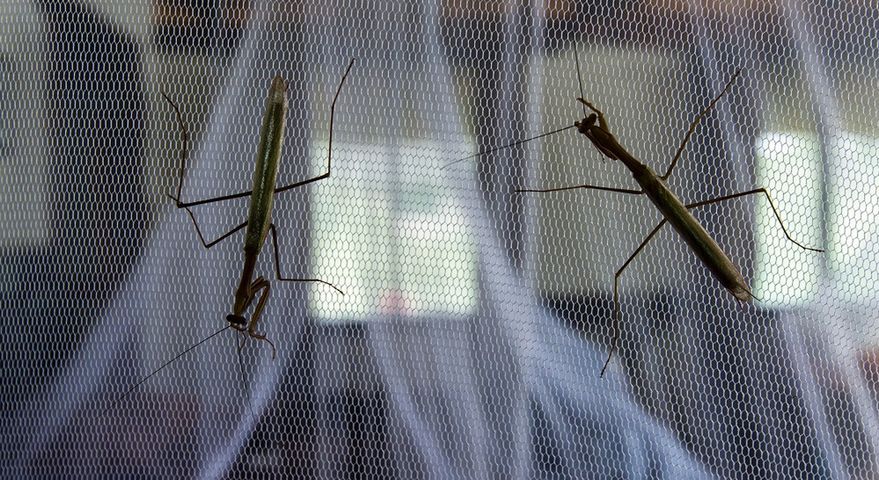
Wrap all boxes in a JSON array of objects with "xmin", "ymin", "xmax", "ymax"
[{"xmin": 754, "ymin": 132, "xmax": 879, "ymax": 308}]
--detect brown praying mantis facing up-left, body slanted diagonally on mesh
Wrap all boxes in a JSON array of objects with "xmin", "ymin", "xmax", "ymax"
[{"xmin": 447, "ymin": 60, "xmax": 824, "ymax": 376}]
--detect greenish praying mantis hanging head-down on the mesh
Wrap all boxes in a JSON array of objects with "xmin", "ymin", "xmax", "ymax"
[{"xmin": 117, "ymin": 59, "xmax": 354, "ymax": 402}]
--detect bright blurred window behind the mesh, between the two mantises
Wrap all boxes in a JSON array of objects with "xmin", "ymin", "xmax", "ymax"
[{"xmin": 310, "ymin": 140, "xmax": 477, "ymax": 322}]
